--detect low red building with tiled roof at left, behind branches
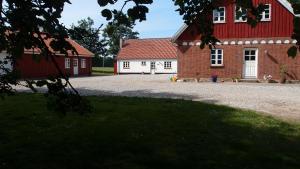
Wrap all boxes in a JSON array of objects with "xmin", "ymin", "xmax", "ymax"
[{"xmin": 14, "ymin": 38, "xmax": 94, "ymax": 78}]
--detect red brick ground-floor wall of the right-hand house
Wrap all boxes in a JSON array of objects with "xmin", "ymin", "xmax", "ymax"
[{"xmin": 178, "ymin": 41, "xmax": 300, "ymax": 80}]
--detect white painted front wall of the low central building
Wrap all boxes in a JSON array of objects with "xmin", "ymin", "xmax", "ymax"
[{"xmin": 118, "ymin": 59, "xmax": 177, "ymax": 74}]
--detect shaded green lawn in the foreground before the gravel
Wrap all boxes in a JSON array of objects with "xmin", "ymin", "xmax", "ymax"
[{"xmin": 0, "ymin": 94, "xmax": 300, "ymax": 169}]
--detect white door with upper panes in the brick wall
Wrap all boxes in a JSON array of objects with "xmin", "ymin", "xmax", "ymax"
[{"xmin": 243, "ymin": 49, "xmax": 258, "ymax": 79}]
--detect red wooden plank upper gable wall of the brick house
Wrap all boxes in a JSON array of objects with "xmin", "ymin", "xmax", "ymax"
[{"xmin": 178, "ymin": 0, "xmax": 293, "ymax": 41}]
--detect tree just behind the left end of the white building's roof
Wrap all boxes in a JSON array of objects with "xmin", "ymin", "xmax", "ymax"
[{"xmin": 102, "ymin": 12, "xmax": 139, "ymax": 58}]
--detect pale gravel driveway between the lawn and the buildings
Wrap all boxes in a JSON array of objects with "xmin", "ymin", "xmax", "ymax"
[{"xmin": 66, "ymin": 75, "xmax": 300, "ymax": 121}]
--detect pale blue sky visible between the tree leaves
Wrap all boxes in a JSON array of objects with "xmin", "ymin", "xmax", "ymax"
[{"xmin": 61, "ymin": 0, "xmax": 183, "ymax": 38}]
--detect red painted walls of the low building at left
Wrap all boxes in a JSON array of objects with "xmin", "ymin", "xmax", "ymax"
[{"xmin": 15, "ymin": 54, "xmax": 92, "ymax": 78}]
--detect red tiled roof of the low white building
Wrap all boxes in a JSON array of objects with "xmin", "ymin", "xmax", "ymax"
[{"xmin": 117, "ymin": 38, "xmax": 177, "ymax": 60}]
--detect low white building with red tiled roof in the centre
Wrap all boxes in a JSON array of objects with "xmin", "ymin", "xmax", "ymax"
[{"xmin": 115, "ymin": 38, "xmax": 177, "ymax": 74}]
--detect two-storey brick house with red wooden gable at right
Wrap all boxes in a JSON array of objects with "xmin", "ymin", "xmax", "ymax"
[{"xmin": 174, "ymin": 0, "xmax": 300, "ymax": 80}]
